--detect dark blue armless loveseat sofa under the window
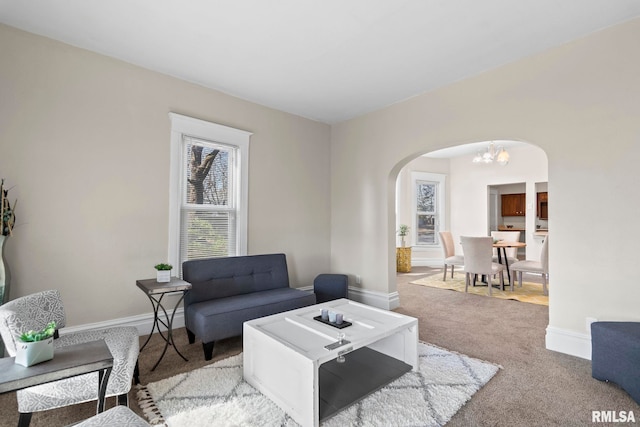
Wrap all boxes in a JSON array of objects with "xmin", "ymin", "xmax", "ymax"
[{"xmin": 182, "ymin": 254, "xmax": 316, "ymax": 360}]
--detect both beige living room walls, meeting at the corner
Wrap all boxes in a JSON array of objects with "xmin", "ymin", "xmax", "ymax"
[{"xmin": 0, "ymin": 19, "xmax": 640, "ymax": 358}]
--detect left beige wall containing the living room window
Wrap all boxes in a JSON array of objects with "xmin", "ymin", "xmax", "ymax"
[{"xmin": 0, "ymin": 25, "xmax": 330, "ymax": 325}]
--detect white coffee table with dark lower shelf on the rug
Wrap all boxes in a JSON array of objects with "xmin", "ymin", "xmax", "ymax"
[{"xmin": 243, "ymin": 299, "xmax": 418, "ymax": 427}]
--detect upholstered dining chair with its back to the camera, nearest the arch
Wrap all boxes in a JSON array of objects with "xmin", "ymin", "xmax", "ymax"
[{"xmin": 460, "ymin": 236, "xmax": 505, "ymax": 295}]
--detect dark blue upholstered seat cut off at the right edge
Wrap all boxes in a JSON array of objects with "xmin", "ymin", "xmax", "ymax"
[{"xmin": 591, "ymin": 322, "xmax": 640, "ymax": 404}]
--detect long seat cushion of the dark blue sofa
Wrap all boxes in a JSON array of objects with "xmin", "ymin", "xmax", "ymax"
[{"xmin": 186, "ymin": 288, "xmax": 316, "ymax": 343}]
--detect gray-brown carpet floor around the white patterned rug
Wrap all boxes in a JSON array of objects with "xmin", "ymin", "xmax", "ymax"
[{"xmin": 0, "ymin": 267, "xmax": 640, "ymax": 427}]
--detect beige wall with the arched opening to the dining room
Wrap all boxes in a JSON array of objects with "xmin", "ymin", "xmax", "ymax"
[{"xmin": 331, "ymin": 19, "xmax": 640, "ymax": 356}]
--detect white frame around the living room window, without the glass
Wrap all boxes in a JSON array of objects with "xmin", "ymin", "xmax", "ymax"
[{"xmin": 167, "ymin": 113, "xmax": 252, "ymax": 277}]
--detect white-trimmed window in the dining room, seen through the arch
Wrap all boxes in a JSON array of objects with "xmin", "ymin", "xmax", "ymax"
[{"xmin": 411, "ymin": 172, "xmax": 445, "ymax": 246}]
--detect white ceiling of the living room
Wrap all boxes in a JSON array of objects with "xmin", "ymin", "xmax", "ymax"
[{"xmin": 0, "ymin": 0, "xmax": 640, "ymax": 123}]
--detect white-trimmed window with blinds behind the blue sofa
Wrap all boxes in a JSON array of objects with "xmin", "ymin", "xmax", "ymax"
[{"xmin": 169, "ymin": 113, "xmax": 251, "ymax": 272}]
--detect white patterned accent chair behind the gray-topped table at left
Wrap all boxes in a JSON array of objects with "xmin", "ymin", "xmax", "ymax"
[{"xmin": 0, "ymin": 290, "xmax": 140, "ymax": 426}]
